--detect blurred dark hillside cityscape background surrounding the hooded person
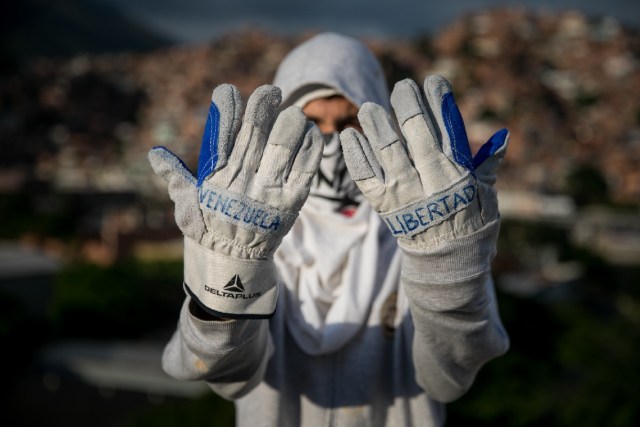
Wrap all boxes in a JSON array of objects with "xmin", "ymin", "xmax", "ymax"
[{"xmin": 0, "ymin": 0, "xmax": 640, "ymax": 427}]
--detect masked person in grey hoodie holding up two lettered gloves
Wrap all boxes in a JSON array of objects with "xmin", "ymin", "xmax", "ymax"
[{"xmin": 149, "ymin": 33, "xmax": 509, "ymax": 427}]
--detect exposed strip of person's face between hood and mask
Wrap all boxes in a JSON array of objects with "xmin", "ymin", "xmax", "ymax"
[{"xmin": 302, "ymin": 95, "xmax": 362, "ymax": 134}]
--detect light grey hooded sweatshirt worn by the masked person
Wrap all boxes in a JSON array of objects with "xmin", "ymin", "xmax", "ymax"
[{"xmin": 163, "ymin": 33, "xmax": 508, "ymax": 427}]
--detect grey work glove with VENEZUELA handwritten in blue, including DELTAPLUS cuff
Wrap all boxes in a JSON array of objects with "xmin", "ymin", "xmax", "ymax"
[{"xmin": 148, "ymin": 84, "xmax": 322, "ymax": 318}]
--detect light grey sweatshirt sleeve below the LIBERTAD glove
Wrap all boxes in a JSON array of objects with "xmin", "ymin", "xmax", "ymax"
[{"xmin": 401, "ymin": 220, "xmax": 509, "ymax": 402}]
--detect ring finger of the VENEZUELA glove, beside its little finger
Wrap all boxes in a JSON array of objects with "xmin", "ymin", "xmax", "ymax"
[{"xmin": 256, "ymin": 106, "xmax": 307, "ymax": 193}]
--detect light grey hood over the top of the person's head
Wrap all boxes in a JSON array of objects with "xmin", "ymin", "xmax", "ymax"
[{"xmin": 273, "ymin": 32, "xmax": 389, "ymax": 109}]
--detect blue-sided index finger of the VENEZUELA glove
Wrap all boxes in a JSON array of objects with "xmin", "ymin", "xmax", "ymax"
[{"xmin": 198, "ymin": 84, "xmax": 242, "ymax": 186}]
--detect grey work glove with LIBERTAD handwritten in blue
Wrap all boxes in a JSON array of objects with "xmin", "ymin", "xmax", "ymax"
[{"xmin": 340, "ymin": 75, "xmax": 508, "ymax": 253}]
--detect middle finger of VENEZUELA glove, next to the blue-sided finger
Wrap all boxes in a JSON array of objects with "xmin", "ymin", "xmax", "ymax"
[{"xmin": 227, "ymin": 85, "xmax": 282, "ymax": 181}]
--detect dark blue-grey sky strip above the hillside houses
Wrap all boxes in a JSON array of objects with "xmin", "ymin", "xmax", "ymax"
[{"xmin": 101, "ymin": 0, "xmax": 640, "ymax": 43}]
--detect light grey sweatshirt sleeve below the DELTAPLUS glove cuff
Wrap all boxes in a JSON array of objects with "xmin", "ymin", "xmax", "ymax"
[{"xmin": 162, "ymin": 297, "xmax": 272, "ymax": 400}]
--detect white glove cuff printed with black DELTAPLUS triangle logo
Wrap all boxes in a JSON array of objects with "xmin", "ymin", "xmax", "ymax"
[{"xmin": 184, "ymin": 237, "xmax": 278, "ymax": 319}]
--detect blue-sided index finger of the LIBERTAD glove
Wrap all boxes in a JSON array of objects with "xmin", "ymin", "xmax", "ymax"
[{"xmin": 424, "ymin": 75, "xmax": 473, "ymax": 170}]
